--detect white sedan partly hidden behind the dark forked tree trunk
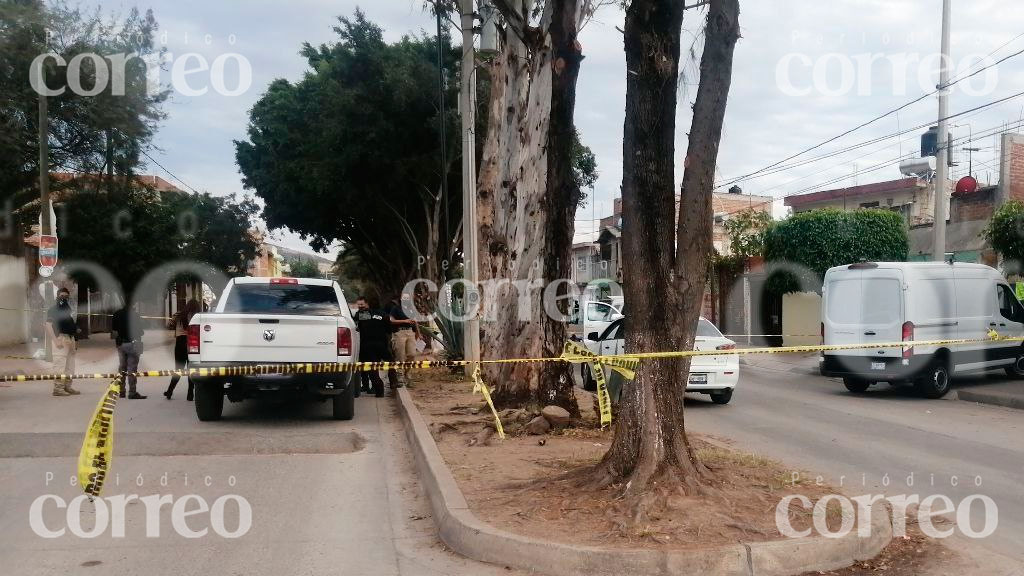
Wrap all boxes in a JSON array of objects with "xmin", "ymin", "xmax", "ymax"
[{"xmin": 583, "ymin": 318, "xmax": 739, "ymax": 404}]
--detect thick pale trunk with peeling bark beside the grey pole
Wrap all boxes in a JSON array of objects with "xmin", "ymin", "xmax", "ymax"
[{"xmin": 477, "ymin": 0, "xmax": 585, "ymax": 415}]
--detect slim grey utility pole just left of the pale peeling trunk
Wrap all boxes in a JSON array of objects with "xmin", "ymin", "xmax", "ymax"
[{"xmin": 459, "ymin": 0, "xmax": 480, "ymax": 362}]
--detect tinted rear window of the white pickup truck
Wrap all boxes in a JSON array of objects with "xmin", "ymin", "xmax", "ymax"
[{"xmin": 224, "ymin": 284, "xmax": 341, "ymax": 316}]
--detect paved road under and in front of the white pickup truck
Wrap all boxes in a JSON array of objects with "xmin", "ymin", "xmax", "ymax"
[{"xmin": 0, "ymin": 366, "xmax": 528, "ymax": 576}]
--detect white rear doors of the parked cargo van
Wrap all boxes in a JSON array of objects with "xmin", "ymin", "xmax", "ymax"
[{"xmin": 822, "ymin": 268, "xmax": 903, "ymax": 358}]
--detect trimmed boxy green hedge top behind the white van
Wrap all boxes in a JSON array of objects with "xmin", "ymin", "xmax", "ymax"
[{"xmin": 765, "ymin": 209, "xmax": 909, "ymax": 293}]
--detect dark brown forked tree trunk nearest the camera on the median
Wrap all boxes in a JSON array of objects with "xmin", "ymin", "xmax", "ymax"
[{"xmin": 598, "ymin": 0, "xmax": 739, "ymax": 506}]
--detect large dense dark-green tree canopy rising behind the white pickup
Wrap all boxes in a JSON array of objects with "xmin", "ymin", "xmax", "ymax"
[{"xmin": 236, "ymin": 10, "xmax": 597, "ymax": 292}]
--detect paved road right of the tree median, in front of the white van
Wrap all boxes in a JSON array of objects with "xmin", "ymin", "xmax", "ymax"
[{"xmin": 686, "ymin": 365, "xmax": 1024, "ymax": 574}]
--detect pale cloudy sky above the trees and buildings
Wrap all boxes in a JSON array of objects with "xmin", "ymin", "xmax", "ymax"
[{"xmin": 81, "ymin": 0, "xmax": 1024, "ymax": 250}]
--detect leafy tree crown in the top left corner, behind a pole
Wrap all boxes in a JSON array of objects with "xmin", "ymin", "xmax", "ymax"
[{"xmin": 0, "ymin": 0, "xmax": 169, "ymax": 207}]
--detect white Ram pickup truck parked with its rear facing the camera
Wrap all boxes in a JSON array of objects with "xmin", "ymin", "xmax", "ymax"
[{"xmin": 187, "ymin": 278, "xmax": 358, "ymax": 421}]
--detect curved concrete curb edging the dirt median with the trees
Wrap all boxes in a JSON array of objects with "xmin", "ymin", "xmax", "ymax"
[{"xmin": 397, "ymin": 388, "xmax": 892, "ymax": 576}]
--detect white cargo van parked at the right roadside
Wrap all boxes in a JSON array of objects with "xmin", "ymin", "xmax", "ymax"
[{"xmin": 820, "ymin": 262, "xmax": 1024, "ymax": 398}]
